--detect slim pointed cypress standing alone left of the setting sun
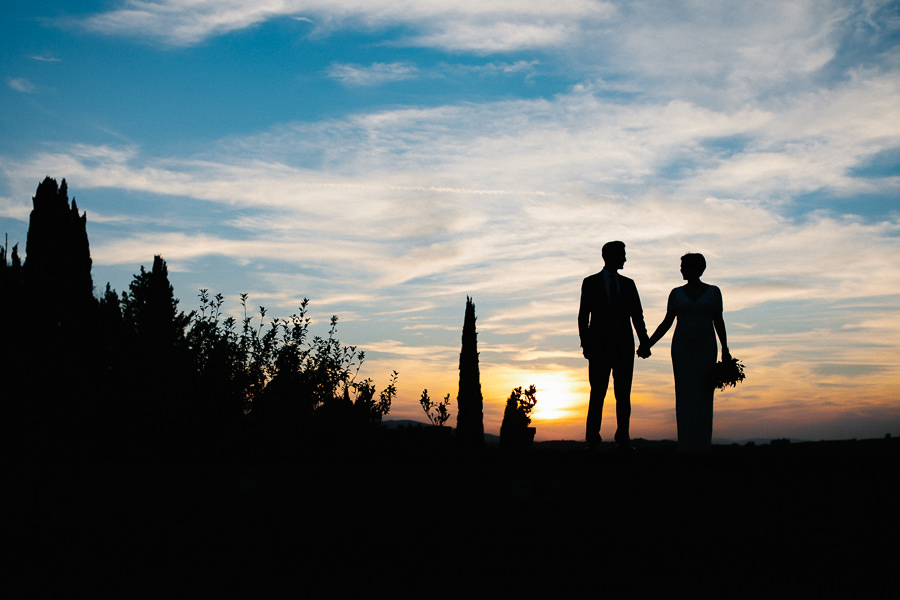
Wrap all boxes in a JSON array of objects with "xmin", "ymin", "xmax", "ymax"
[{"xmin": 456, "ymin": 296, "xmax": 484, "ymax": 447}]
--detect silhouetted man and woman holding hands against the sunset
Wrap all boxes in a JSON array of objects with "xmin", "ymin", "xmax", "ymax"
[{"xmin": 578, "ymin": 242, "xmax": 730, "ymax": 453}]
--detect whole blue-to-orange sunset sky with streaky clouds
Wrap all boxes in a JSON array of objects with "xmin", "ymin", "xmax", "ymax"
[{"xmin": 0, "ymin": 0, "xmax": 900, "ymax": 440}]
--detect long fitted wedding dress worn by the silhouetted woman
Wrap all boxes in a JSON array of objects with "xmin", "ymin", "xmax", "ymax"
[{"xmin": 669, "ymin": 285, "xmax": 722, "ymax": 453}]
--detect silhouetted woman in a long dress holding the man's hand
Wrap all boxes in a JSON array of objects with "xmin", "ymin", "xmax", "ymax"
[{"xmin": 637, "ymin": 253, "xmax": 731, "ymax": 454}]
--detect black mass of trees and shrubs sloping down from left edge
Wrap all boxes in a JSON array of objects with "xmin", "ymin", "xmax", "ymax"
[{"xmin": 0, "ymin": 177, "xmax": 397, "ymax": 453}]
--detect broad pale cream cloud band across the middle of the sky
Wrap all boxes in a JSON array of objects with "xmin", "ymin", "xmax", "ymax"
[{"xmin": 7, "ymin": 69, "xmax": 900, "ymax": 314}]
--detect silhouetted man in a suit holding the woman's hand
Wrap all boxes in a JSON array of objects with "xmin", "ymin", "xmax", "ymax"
[{"xmin": 578, "ymin": 241, "xmax": 650, "ymax": 449}]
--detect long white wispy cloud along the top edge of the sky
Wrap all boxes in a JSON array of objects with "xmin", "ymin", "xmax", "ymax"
[{"xmin": 82, "ymin": 0, "xmax": 614, "ymax": 52}]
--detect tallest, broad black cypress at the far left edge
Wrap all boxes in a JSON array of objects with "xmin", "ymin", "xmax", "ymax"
[{"xmin": 0, "ymin": 177, "xmax": 96, "ymax": 449}]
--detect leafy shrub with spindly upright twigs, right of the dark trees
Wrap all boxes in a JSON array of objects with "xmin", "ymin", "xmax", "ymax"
[{"xmin": 187, "ymin": 290, "xmax": 397, "ymax": 448}]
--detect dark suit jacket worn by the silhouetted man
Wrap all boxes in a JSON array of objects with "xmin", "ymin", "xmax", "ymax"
[{"xmin": 578, "ymin": 271, "xmax": 647, "ymax": 358}]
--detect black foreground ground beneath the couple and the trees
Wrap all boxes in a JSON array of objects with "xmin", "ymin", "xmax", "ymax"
[{"xmin": 0, "ymin": 436, "xmax": 900, "ymax": 597}]
